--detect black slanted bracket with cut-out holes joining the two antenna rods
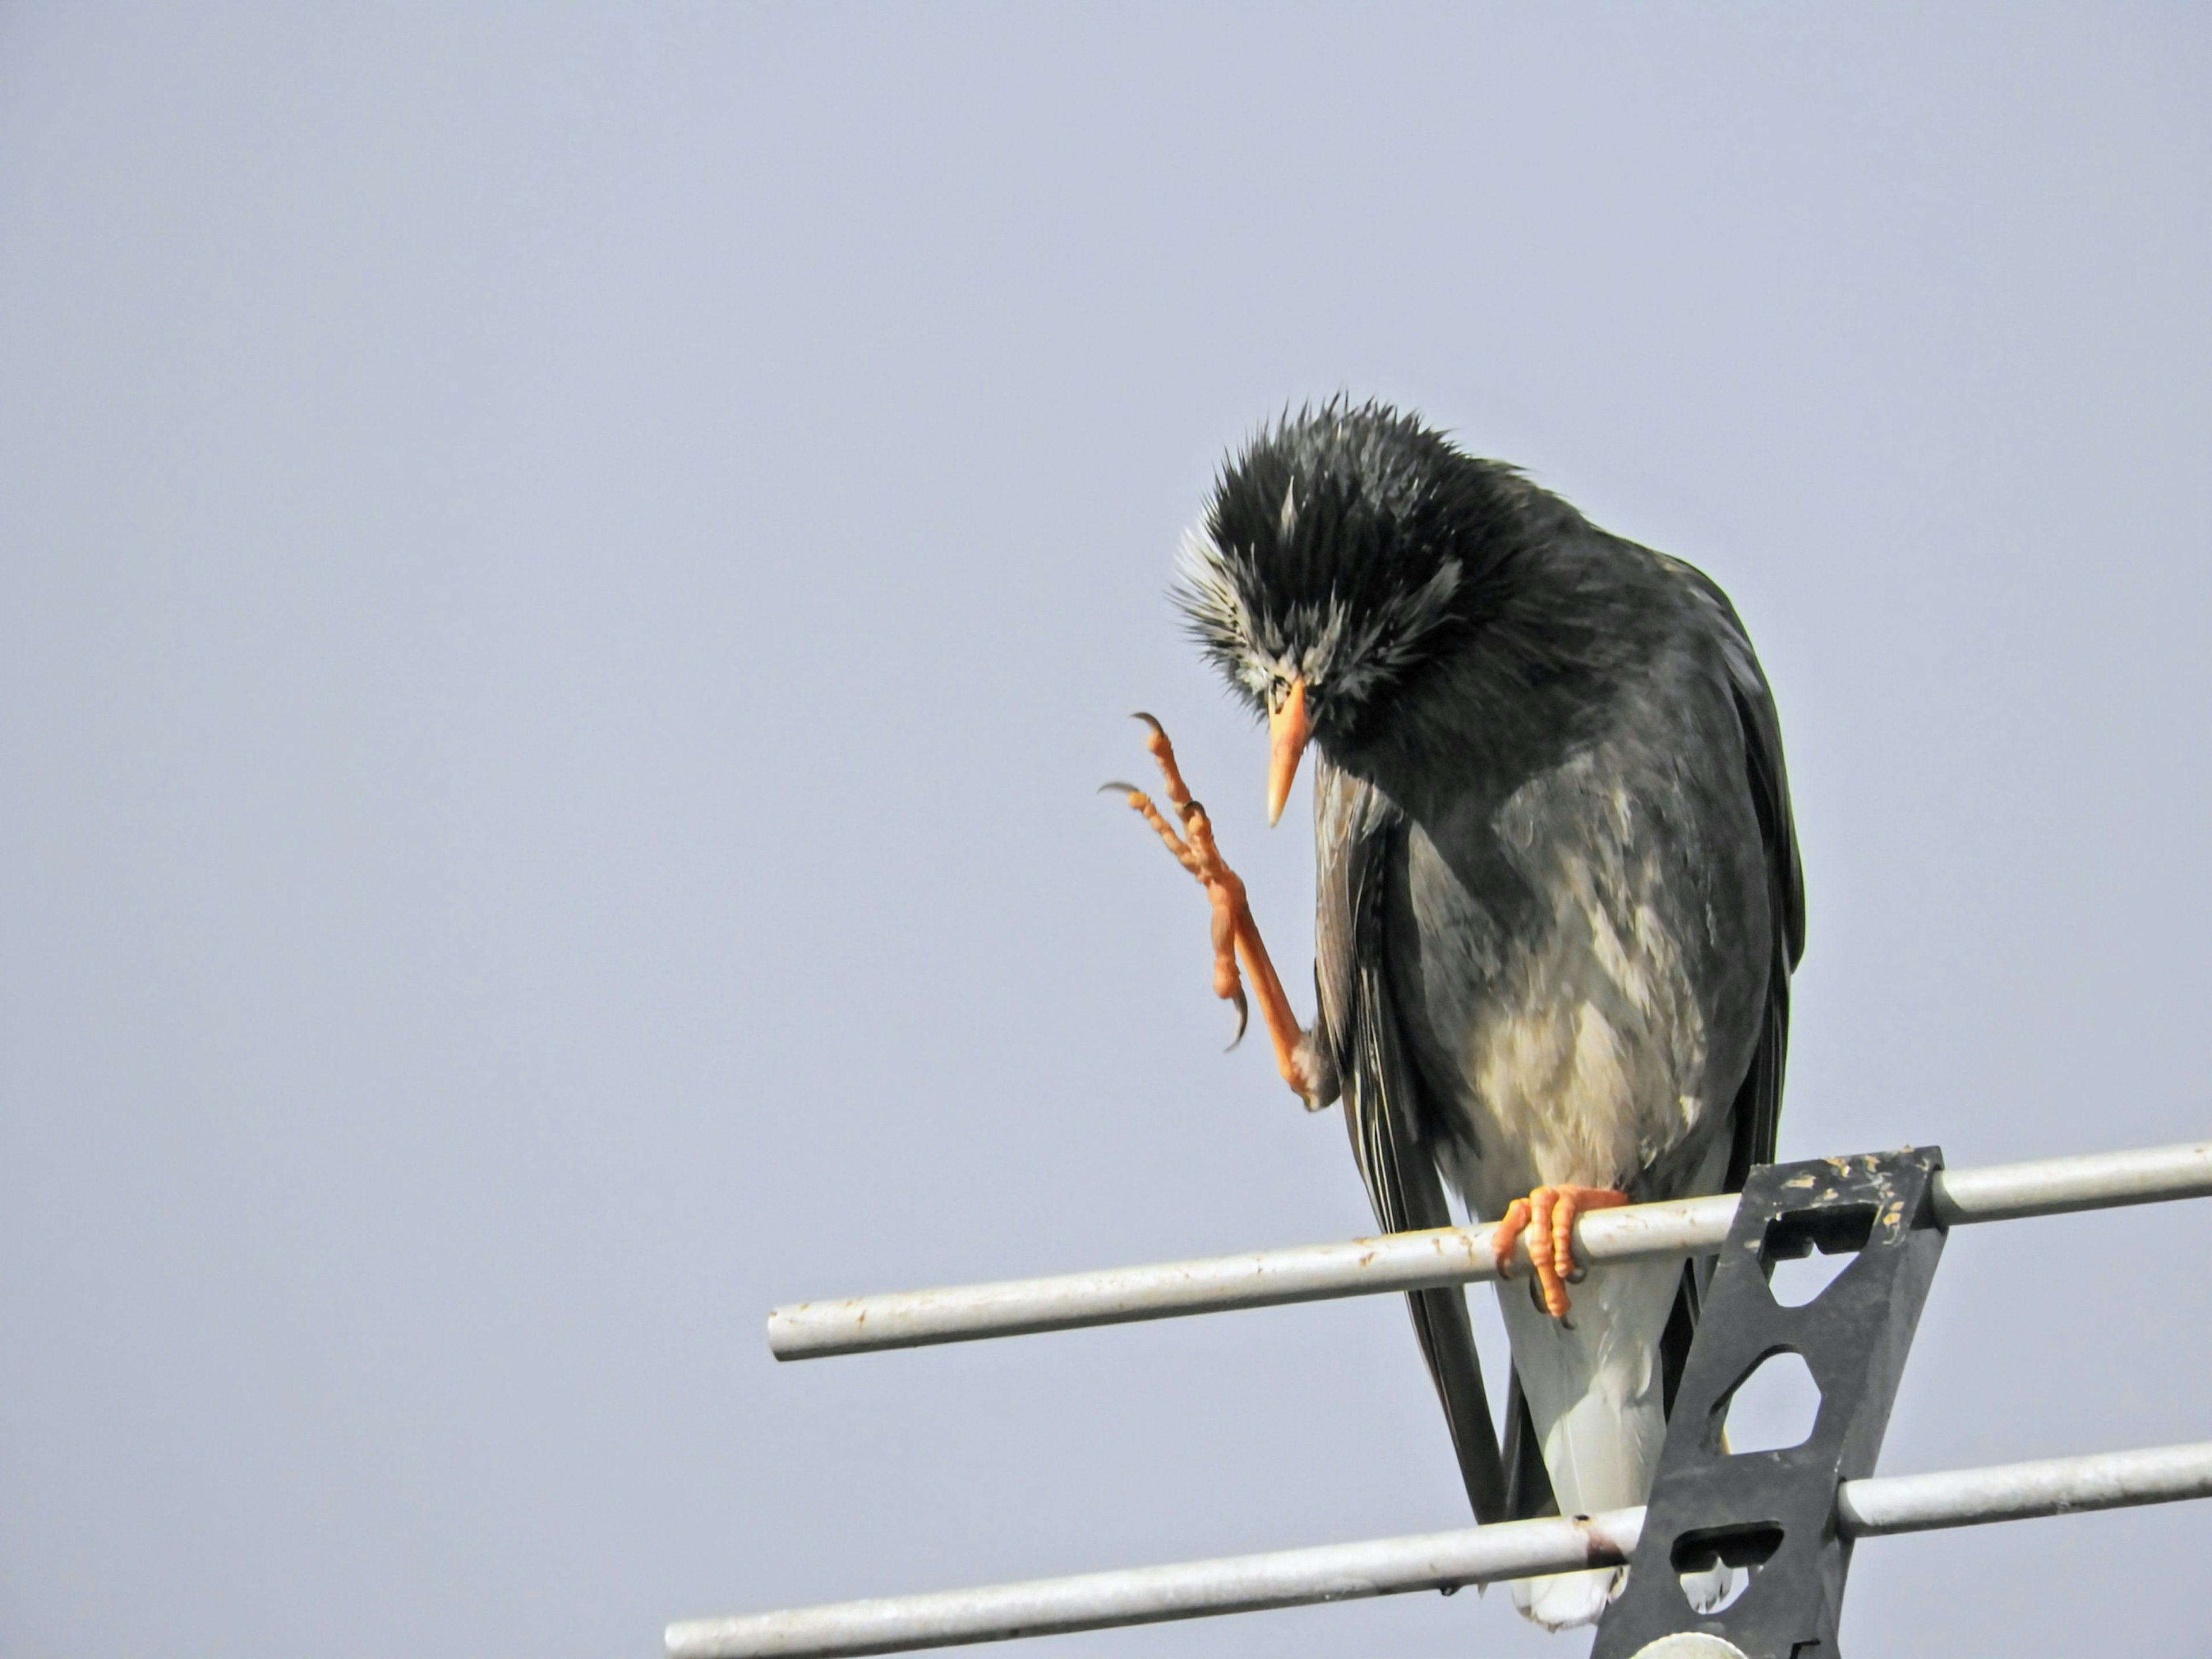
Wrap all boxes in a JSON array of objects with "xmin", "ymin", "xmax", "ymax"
[{"xmin": 1590, "ymin": 1146, "xmax": 1944, "ymax": 1659}]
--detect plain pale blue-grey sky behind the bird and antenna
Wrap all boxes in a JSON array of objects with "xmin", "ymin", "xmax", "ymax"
[{"xmin": 0, "ymin": 5, "xmax": 2212, "ymax": 1659}]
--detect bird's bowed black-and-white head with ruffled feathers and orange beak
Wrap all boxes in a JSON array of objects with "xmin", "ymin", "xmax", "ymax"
[{"xmin": 1175, "ymin": 400, "xmax": 1515, "ymax": 823}]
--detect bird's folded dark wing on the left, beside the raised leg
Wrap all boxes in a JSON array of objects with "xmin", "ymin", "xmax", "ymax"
[{"xmin": 1314, "ymin": 761, "xmax": 1511, "ymax": 1524}]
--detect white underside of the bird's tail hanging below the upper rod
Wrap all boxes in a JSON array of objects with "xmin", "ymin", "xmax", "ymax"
[{"xmin": 1498, "ymin": 1261, "xmax": 1699, "ymax": 1630}]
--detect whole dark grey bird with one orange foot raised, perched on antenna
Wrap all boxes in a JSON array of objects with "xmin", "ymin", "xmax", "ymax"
[{"xmin": 1111, "ymin": 403, "xmax": 1805, "ymax": 1628}]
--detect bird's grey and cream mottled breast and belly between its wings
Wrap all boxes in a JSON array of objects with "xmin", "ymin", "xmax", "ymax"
[{"xmin": 1367, "ymin": 637, "xmax": 1772, "ymax": 1214}]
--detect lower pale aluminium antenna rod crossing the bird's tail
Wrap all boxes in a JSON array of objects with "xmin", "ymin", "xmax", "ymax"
[{"xmin": 668, "ymin": 1440, "xmax": 2212, "ymax": 1659}]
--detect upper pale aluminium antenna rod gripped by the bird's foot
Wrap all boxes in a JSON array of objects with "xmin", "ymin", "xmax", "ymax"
[{"xmin": 767, "ymin": 1141, "xmax": 2212, "ymax": 1361}]
